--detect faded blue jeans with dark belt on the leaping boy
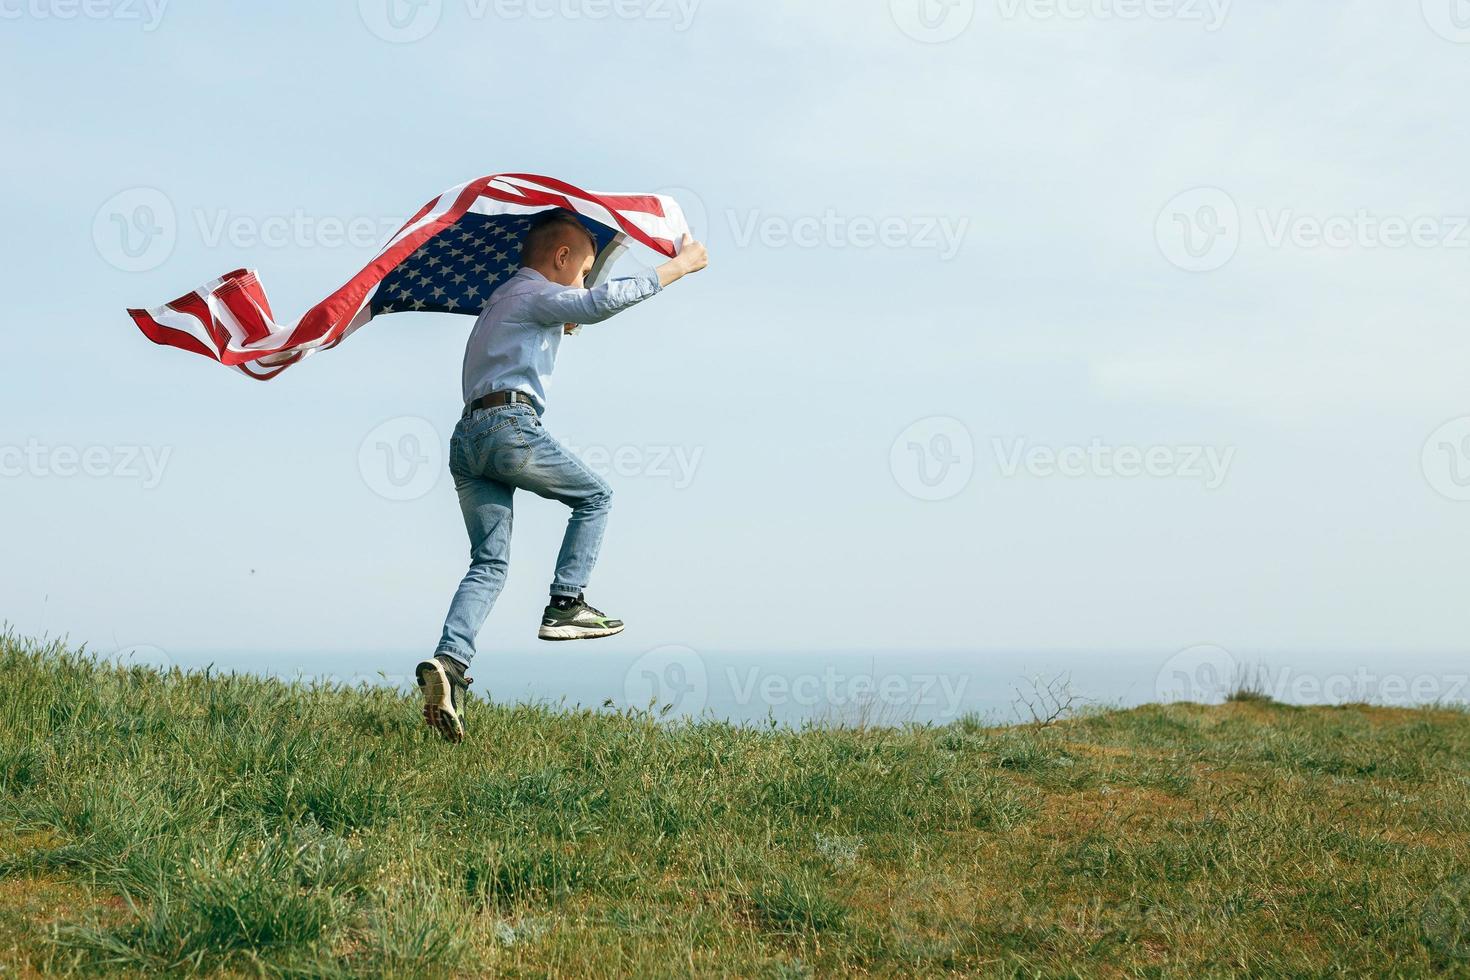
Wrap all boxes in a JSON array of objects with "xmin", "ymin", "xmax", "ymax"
[{"xmin": 437, "ymin": 404, "xmax": 613, "ymax": 666}]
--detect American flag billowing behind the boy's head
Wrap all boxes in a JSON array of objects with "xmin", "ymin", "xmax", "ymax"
[{"xmin": 128, "ymin": 173, "xmax": 688, "ymax": 381}]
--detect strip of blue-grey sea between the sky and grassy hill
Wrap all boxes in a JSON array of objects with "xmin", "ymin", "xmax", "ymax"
[{"xmin": 106, "ymin": 644, "xmax": 1470, "ymax": 726}]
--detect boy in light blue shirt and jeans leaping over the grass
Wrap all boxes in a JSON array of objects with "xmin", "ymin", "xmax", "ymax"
[{"xmin": 415, "ymin": 210, "xmax": 709, "ymax": 742}]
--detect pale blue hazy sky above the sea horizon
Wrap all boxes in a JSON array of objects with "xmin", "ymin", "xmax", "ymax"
[{"xmin": 0, "ymin": 0, "xmax": 1470, "ymax": 705}]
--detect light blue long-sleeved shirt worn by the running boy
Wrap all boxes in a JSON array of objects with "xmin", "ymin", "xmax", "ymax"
[{"xmin": 465, "ymin": 269, "xmax": 660, "ymax": 414}]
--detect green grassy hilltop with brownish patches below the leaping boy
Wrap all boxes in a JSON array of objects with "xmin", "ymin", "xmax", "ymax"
[{"xmin": 0, "ymin": 638, "xmax": 1470, "ymax": 977}]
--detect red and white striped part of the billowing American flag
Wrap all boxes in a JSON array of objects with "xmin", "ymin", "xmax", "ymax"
[{"xmin": 128, "ymin": 173, "xmax": 688, "ymax": 381}]
